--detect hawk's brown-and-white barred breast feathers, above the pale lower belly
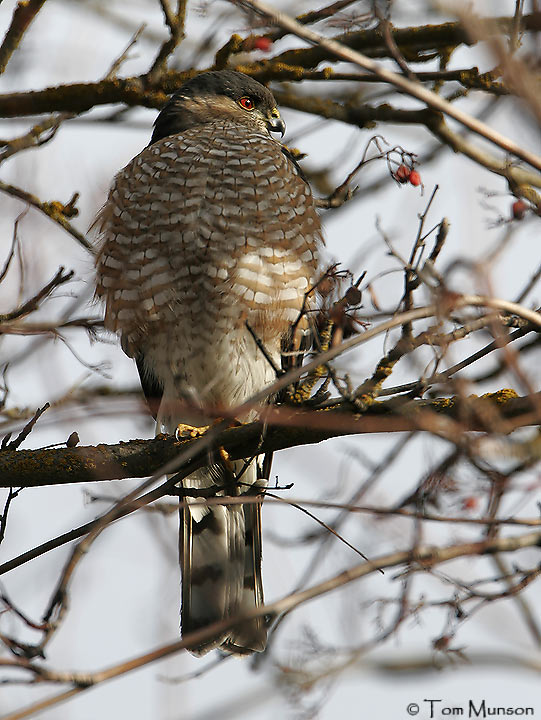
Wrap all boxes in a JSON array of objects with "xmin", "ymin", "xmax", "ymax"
[{"xmin": 96, "ymin": 121, "xmax": 323, "ymax": 356}]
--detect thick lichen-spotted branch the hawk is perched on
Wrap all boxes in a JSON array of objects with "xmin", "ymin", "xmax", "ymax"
[{"xmin": 0, "ymin": 392, "xmax": 541, "ymax": 487}]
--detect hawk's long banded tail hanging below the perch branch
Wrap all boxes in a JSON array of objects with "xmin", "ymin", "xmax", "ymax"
[{"xmin": 180, "ymin": 461, "xmax": 267, "ymax": 655}]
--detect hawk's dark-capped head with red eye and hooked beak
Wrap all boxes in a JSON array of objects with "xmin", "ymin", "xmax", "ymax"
[{"xmin": 150, "ymin": 70, "xmax": 285, "ymax": 144}]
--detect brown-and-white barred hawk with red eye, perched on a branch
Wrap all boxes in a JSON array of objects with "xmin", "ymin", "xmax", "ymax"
[{"xmin": 97, "ymin": 70, "xmax": 323, "ymax": 655}]
